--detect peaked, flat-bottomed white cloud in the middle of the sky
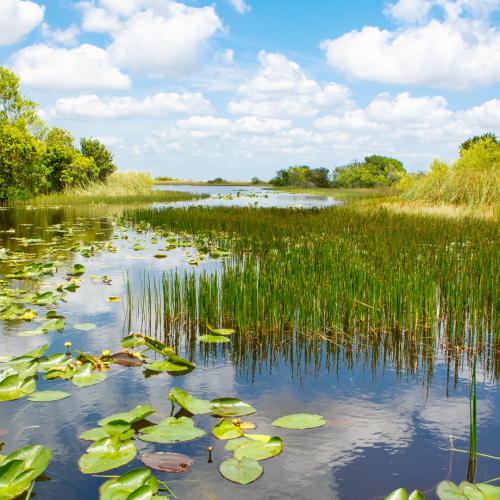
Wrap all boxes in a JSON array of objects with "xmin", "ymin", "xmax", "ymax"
[{"xmin": 228, "ymin": 50, "xmax": 350, "ymax": 117}]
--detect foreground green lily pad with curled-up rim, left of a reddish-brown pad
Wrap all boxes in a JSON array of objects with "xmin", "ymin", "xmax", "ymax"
[{"xmin": 78, "ymin": 435, "xmax": 137, "ymax": 474}]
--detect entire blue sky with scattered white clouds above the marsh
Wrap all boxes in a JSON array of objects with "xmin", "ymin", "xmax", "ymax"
[{"xmin": 0, "ymin": 0, "xmax": 500, "ymax": 180}]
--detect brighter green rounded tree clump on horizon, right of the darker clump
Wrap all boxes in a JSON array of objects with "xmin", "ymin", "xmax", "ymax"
[{"xmin": 332, "ymin": 155, "xmax": 405, "ymax": 188}]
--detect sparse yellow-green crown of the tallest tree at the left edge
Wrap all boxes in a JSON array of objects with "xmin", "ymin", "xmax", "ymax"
[{"xmin": 0, "ymin": 66, "xmax": 47, "ymax": 139}]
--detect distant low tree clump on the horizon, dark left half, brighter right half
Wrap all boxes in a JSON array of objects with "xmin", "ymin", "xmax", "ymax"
[{"xmin": 269, "ymin": 155, "xmax": 406, "ymax": 188}]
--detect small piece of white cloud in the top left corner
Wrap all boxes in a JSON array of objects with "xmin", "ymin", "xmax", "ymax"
[{"xmin": 0, "ymin": 0, "xmax": 45, "ymax": 45}]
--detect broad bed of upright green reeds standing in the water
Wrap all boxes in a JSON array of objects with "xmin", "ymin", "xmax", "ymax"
[{"xmin": 121, "ymin": 203, "xmax": 500, "ymax": 378}]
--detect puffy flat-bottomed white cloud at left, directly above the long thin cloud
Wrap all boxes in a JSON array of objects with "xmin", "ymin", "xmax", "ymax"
[{"xmin": 11, "ymin": 44, "xmax": 132, "ymax": 91}]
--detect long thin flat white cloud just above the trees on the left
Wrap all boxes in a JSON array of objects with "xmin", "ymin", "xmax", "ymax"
[{"xmin": 47, "ymin": 92, "xmax": 213, "ymax": 119}]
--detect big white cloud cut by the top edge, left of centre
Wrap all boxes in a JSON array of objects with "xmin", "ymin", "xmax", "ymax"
[{"xmin": 79, "ymin": 0, "xmax": 222, "ymax": 78}]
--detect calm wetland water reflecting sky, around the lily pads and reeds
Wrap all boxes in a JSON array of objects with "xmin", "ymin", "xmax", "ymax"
[{"xmin": 0, "ymin": 186, "xmax": 500, "ymax": 500}]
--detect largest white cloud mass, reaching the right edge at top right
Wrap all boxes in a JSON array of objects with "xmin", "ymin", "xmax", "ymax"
[{"xmin": 320, "ymin": 0, "xmax": 500, "ymax": 90}]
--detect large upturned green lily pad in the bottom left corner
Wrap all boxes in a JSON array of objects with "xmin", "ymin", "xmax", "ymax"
[{"xmin": 0, "ymin": 445, "xmax": 51, "ymax": 500}]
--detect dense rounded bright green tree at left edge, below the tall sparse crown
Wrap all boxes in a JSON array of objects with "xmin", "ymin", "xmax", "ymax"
[{"xmin": 0, "ymin": 120, "xmax": 47, "ymax": 202}]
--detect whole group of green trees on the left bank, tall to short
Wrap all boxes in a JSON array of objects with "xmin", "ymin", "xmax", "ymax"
[{"xmin": 0, "ymin": 66, "xmax": 118, "ymax": 202}]
